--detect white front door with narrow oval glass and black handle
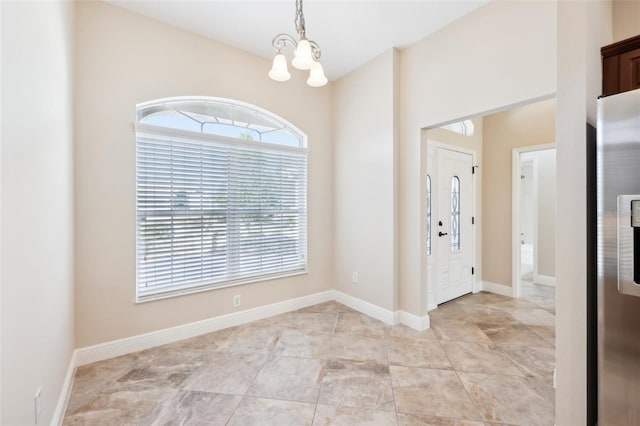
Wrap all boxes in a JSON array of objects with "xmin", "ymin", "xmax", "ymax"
[{"xmin": 432, "ymin": 148, "xmax": 473, "ymax": 304}]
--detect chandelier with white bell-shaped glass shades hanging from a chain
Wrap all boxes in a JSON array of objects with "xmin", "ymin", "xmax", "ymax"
[{"xmin": 269, "ymin": 0, "xmax": 327, "ymax": 87}]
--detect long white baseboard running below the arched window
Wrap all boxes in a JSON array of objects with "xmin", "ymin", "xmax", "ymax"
[{"xmin": 75, "ymin": 290, "xmax": 332, "ymax": 365}]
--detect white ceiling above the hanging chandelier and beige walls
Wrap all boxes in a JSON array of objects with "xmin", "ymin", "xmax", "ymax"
[{"xmin": 108, "ymin": 0, "xmax": 489, "ymax": 80}]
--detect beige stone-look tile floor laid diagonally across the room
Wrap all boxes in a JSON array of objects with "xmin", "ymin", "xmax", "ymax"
[{"xmin": 64, "ymin": 288, "xmax": 555, "ymax": 426}]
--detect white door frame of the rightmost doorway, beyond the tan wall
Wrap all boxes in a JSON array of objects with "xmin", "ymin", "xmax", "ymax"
[{"xmin": 511, "ymin": 143, "xmax": 556, "ymax": 297}]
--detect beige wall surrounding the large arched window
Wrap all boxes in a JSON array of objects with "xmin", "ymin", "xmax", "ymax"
[{"xmin": 75, "ymin": 2, "xmax": 333, "ymax": 347}]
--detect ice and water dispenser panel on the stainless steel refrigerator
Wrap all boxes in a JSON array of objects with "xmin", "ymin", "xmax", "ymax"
[{"xmin": 618, "ymin": 195, "xmax": 640, "ymax": 297}]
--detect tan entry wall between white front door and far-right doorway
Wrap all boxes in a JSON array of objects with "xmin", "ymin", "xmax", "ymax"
[{"xmin": 482, "ymin": 99, "xmax": 556, "ymax": 286}]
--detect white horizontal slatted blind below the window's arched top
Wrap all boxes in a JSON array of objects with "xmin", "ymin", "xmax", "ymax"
[{"xmin": 136, "ymin": 133, "xmax": 307, "ymax": 300}]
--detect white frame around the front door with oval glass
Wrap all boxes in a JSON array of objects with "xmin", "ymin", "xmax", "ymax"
[{"xmin": 421, "ymin": 138, "xmax": 482, "ymax": 311}]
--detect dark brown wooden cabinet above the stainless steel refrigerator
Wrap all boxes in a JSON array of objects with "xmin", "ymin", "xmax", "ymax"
[{"xmin": 600, "ymin": 35, "xmax": 640, "ymax": 96}]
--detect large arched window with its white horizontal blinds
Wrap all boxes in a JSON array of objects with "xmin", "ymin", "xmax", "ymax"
[{"xmin": 136, "ymin": 98, "xmax": 307, "ymax": 301}]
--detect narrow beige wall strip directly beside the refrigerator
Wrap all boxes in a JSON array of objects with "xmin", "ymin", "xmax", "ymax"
[{"xmin": 556, "ymin": 1, "xmax": 612, "ymax": 426}]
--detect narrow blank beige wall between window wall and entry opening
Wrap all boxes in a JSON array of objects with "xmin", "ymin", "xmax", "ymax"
[{"xmin": 332, "ymin": 49, "xmax": 398, "ymax": 310}]
